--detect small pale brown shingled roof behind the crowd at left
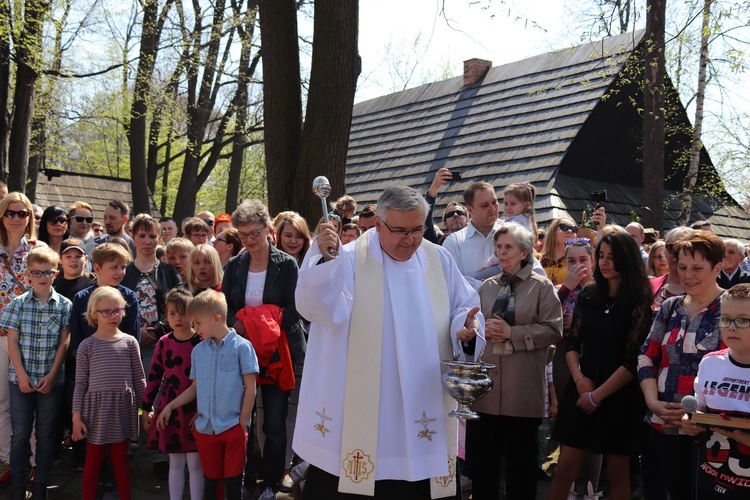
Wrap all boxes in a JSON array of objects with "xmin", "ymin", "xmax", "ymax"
[{"xmin": 35, "ymin": 170, "xmax": 160, "ymax": 219}]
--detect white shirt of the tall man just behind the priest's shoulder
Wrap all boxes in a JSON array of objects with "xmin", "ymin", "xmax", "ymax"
[{"xmin": 443, "ymin": 221, "xmax": 500, "ymax": 290}]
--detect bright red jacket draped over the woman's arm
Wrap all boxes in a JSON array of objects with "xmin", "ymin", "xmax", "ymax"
[{"xmin": 237, "ymin": 304, "xmax": 295, "ymax": 391}]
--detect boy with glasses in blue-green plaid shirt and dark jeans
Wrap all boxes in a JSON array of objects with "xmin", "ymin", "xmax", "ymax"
[{"xmin": 0, "ymin": 247, "xmax": 72, "ymax": 499}]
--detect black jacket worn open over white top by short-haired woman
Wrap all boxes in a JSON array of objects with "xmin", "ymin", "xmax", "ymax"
[{"xmin": 221, "ymin": 246, "xmax": 306, "ymax": 363}]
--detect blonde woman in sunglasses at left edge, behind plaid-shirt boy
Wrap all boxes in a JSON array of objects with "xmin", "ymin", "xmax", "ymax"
[{"xmin": 0, "ymin": 192, "xmax": 47, "ymax": 485}]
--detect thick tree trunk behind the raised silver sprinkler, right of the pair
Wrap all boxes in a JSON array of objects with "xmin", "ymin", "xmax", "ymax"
[{"xmin": 296, "ymin": 0, "xmax": 361, "ymax": 224}]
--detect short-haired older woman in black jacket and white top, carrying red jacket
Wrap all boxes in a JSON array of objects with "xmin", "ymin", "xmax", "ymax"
[{"xmin": 221, "ymin": 200, "xmax": 305, "ymax": 493}]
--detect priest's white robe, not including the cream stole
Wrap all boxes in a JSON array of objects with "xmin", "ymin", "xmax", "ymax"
[{"xmin": 293, "ymin": 234, "xmax": 485, "ymax": 481}]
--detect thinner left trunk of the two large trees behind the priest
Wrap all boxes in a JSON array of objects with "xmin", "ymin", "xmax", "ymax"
[{"xmin": 260, "ymin": 0, "xmax": 304, "ymax": 214}]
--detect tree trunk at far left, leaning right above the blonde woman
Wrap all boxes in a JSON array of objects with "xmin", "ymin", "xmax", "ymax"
[{"xmin": 8, "ymin": 0, "xmax": 50, "ymax": 193}]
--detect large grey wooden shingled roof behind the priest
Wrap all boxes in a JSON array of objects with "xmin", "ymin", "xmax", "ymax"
[{"xmin": 346, "ymin": 32, "xmax": 750, "ymax": 238}]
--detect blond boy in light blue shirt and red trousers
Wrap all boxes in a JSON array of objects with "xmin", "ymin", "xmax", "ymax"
[{"xmin": 156, "ymin": 290, "xmax": 258, "ymax": 500}]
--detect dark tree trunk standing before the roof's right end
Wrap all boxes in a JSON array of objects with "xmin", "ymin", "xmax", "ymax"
[{"xmin": 643, "ymin": 0, "xmax": 666, "ymax": 231}]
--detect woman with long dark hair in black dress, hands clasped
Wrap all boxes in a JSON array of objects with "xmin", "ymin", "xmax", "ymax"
[{"xmin": 549, "ymin": 229, "xmax": 651, "ymax": 500}]
